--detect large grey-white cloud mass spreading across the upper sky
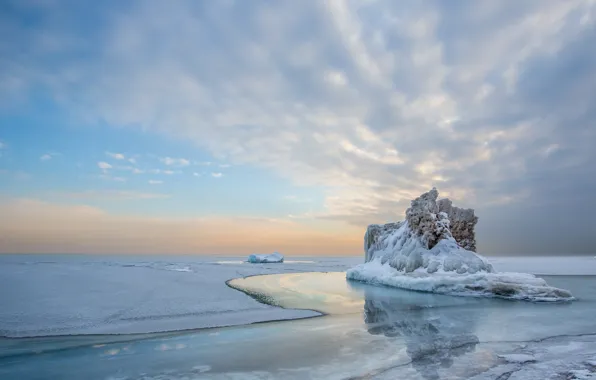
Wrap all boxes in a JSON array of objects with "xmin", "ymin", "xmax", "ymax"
[{"xmin": 0, "ymin": 0, "xmax": 596, "ymax": 252}]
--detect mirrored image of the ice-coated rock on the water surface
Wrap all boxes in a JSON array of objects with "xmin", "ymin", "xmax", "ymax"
[{"xmin": 356, "ymin": 285, "xmax": 479, "ymax": 379}]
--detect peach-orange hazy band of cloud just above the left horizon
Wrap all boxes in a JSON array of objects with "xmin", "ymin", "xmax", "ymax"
[{"xmin": 0, "ymin": 199, "xmax": 362, "ymax": 255}]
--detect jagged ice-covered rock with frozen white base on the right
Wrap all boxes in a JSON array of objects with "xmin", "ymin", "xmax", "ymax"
[{"xmin": 346, "ymin": 188, "xmax": 573, "ymax": 301}]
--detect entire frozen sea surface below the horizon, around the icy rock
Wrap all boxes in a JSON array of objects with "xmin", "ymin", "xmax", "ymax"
[{"xmin": 0, "ymin": 255, "xmax": 596, "ymax": 380}]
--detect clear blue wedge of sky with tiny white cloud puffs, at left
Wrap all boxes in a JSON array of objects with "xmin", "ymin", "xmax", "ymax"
[{"xmin": 0, "ymin": 95, "xmax": 323, "ymax": 218}]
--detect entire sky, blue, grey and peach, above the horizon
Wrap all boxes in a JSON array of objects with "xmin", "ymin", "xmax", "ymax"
[{"xmin": 0, "ymin": 0, "xmax": 596, "ymax": 255}]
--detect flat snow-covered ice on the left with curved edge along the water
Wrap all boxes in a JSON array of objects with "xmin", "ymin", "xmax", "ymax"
[{"xmin": 0, "ymin": 255, "xmax": 358, "ymax": 337}]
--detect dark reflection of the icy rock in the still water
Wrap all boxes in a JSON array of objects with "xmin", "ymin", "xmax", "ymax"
[{"xmin": 364, "ymin": 292, "xmax": 478, "ymax": 379}]
